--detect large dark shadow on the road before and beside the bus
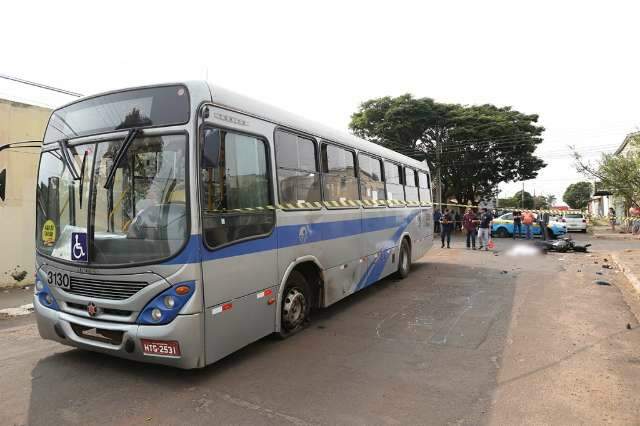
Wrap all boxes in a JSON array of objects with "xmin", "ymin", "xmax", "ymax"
[{"xmin": 28, "ymin": 255, "xmax": 516, "ymax": 425}]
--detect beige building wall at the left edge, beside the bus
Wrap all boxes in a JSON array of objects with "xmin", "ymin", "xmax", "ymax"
[{"xmin": 0, "ymin": 99, "xmax": 51, "ymax": 284}]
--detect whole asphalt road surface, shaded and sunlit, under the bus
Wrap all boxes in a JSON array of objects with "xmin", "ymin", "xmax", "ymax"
[{"xmin": 0, "ymin": 236, "xmax": 640, "ymax": 425}]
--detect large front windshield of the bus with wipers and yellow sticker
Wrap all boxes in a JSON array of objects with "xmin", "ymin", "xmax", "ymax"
[{"xmin": 36, "ymin": 134, "xmax": 188, "ymax": 265}]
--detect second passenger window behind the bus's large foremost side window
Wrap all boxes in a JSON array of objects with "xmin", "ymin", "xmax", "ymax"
[{"xmin": 322, "ymin": 144, "xmax": 359, "ymax": 207}]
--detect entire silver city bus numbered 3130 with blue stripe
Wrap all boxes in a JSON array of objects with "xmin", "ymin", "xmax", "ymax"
[{"xmin": 34, "ymin": 81, "xmax": 433, "ymax": 369}]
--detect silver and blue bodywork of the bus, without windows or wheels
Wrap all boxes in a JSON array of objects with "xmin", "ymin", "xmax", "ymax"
[{"xmin": 34, "ymin": 82, "xmax": 433, "ymax": 369}]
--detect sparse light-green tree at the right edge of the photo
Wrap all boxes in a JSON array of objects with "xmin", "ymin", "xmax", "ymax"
[{"xmin": 574, "ymin": 136, "xmax": 640, "ymax": 209}]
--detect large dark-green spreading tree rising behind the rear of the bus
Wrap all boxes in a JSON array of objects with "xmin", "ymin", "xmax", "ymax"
[{"xmin": 349, "ymin": 94, "xmax": 545, "ymax": 204}]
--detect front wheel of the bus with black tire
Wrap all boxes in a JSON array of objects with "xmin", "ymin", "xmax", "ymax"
[{"xmin": 278, "ymin": 270, "xmax": 311, "ymax": 339}]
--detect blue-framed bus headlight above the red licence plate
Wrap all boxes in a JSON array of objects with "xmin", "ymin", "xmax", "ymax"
[{"xmin": 136, "ymin": 281, "xmax": 196, "ymax": 325}]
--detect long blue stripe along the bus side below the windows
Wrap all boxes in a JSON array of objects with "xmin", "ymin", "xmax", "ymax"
[{"xmin": 165, "ymin": 210, "xmax": 420, "ymax": 265}]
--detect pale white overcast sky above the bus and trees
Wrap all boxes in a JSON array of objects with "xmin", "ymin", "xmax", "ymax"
[{"xmin": 0, "ymin": 0, "xmax": 640, "ymax": 203}]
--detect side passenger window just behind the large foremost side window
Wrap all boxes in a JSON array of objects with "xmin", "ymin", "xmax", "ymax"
[{"xmin": 275, "ymin": 130, "xmax": 321, "ymax": 204}]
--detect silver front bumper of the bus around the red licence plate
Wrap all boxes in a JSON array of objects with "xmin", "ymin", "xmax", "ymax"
[{"xmin": 33, "ymin": 297, "xmax": 204, "ymax": 369}]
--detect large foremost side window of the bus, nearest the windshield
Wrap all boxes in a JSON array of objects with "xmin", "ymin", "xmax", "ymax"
[{"xmin": 200, "ymin": 128, "xmax": 275, "ymax": 248}]
